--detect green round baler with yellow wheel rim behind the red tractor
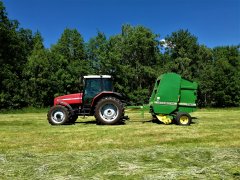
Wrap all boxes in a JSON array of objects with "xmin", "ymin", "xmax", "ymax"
[{"xmin": 149, "ymin": 73, "xmax": 198, "ymax": 125}]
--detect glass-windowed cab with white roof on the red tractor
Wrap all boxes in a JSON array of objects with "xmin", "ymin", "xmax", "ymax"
[{"xmin": 83, "ymin": 75, "xmax": 113, "ymax": 106}]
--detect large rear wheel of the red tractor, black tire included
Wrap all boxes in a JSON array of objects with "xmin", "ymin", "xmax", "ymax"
[{"xmin": 94, "ymin": 97, "xmax": 124, "ymax": 125}]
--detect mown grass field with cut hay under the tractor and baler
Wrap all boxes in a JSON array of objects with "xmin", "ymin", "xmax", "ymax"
[{"xmin": 0, "ymin": 109, "xmax": 240, "ymax": 179}]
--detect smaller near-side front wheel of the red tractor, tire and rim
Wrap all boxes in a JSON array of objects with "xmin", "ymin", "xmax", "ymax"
[{"xmin": 47, "ymin": 105, "xmax": 70, "ymax": 125}]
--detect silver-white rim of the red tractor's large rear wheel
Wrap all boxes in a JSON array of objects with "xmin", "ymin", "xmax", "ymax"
[{"xmin": 100, "ymin": 104, "xmax": 118, "ymax": 122}]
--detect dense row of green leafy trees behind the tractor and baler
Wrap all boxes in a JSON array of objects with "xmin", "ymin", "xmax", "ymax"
[{"xmin": 0, "ymin": 1, "xmax": 240, "ymax": 109}]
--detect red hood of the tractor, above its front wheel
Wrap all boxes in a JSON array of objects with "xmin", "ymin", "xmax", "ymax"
[{"xmin": 54, "ymin": 93, "xmax": 82, "ymax": 105}]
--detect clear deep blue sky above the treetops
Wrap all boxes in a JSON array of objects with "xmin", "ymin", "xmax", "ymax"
[{"xmin": 3, "ymin": 0, "xmax": 240, "ymax": 48}]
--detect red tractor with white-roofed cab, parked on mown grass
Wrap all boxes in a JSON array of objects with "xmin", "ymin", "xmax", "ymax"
[{"xmin": 47, "ymin": 75, "xmax": 127, "ymax": 125}]
